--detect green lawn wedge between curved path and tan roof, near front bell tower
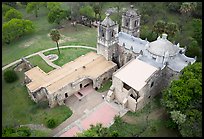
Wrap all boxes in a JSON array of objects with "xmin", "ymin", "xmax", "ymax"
[{"xmin": 44, "ymin": 48, "xmax": 94, "ymax": 66}]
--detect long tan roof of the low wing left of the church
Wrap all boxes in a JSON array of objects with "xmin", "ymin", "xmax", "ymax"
[{"xmin": 25, "ymin": 52, "xmax": 116, "ymax": 94}]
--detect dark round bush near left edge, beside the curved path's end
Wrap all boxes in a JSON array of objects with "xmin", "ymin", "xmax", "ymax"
[{"xmin": 4, "ymin": 70, "xmax": 18, "ymax": 83}]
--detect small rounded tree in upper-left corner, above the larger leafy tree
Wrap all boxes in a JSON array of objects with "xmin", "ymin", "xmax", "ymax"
[{"xmin": 4, "ymin": 9, "xmax": 23, "ymax": 21}]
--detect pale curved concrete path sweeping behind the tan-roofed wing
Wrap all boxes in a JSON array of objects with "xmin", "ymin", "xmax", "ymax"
[{"xmin": 2, "ymin": 46, "xmax": 96, "ymax": 71}]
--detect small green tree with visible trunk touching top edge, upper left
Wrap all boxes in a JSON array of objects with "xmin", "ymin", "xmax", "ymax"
[{"xmin": 26, "ymin": 2, "xmax": 45, "ymax": 18}]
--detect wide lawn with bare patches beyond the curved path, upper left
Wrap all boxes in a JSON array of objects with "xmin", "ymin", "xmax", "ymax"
[{"xmin": 2, "ymin": 7, "xmax": 97, "ymax": 66}]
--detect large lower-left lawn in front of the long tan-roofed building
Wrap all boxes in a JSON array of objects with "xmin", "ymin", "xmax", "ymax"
[{"xmin": 2, "ymin": 72, "xmax": 72, "ymax": 132}]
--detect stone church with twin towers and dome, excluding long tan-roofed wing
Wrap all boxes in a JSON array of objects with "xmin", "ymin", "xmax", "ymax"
[{"xmin": 97, "ymin": 6, "xmax": 196, "ymax": 111}]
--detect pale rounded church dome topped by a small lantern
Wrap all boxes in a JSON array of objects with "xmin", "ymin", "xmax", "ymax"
[{"xmin": 147, "ymin": 34, "xmax": 179, "ymax": 56}]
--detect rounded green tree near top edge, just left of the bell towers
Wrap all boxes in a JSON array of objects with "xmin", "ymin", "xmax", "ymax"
[{"xmin": 79, "ymin": 5, "xmax": 94, "ymax": 19}]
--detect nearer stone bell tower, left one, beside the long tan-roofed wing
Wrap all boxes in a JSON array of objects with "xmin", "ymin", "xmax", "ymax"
[{"xmin": 97, "ymin": 13, "xmax": 118, "ymax": 61}]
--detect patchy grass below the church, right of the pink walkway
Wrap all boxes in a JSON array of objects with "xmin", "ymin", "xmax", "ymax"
[{"xmin": 110, "ymin": 96, "xmax": 179, "ymax": 137}]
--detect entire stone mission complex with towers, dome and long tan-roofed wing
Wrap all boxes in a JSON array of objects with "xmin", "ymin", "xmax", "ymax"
[{"xmin": 25, "ymin": 6, "xmax": 196, "ymax": 111}]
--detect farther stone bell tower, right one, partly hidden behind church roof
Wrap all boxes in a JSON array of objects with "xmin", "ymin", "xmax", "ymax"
[{"xmin": 121, "ymin": 5, "xmax": 141, "ymax": 37}]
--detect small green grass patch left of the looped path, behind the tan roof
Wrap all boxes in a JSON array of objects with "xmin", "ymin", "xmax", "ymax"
[{"xmin": 28, "ymin": 55, "xmax": 54, "ymax": 73}]
